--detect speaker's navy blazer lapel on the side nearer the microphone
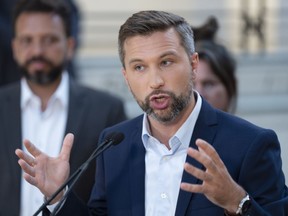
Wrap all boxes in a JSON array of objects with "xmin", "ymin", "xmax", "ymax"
[{"xmin": 129, "ymin": 118, "xmax": 145, "ymax": 216}]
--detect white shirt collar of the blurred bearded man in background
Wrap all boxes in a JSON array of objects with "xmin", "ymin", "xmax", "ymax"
[{"xmin": 21, "ymin": 71, "xmax": 69, "ymax": 109}]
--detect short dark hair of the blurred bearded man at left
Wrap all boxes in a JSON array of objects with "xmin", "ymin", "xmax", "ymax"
[{"xmin": 13, "ymin": 0, "xmax": 71, "ymax": 37}]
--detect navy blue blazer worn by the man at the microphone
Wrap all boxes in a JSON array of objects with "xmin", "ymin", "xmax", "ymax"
[{"xmin": 60, "ymin": 100, "xmax": 288, "ymax": 216}]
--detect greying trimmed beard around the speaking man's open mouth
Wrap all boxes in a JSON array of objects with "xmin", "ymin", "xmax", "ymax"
[{"xmin": 132, "ymin": 79, "xmax": 193, "ymax": 123}]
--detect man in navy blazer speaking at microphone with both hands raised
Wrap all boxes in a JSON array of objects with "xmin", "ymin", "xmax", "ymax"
[{"xmin": 16, "ymin": 11, "xmax": 288, "ymax": 216}]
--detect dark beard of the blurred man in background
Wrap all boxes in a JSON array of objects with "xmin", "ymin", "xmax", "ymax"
[{"xmin": 19, "ymin": 56, "xmax": 65, "ymax": 85}]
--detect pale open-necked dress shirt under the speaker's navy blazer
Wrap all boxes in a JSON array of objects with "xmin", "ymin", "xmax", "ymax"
[{"xmin": 142, "ymin": 92, "xmax": 202, "ymax": 216}]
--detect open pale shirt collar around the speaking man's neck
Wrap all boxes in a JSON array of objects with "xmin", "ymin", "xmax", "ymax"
[{"xmin": 142, "ymin": 91, "xmax": 202, "ymax": 149}]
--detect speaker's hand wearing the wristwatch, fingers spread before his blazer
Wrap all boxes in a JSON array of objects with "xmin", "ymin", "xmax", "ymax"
[{"xmin": 181, "ymin": 139, "xmax": 246, "ymax": 212}]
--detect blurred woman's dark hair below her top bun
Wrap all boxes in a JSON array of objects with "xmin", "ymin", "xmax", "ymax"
[{"xmin": 195, "ymin": 40, "xmax": 237, "ymax": 112}]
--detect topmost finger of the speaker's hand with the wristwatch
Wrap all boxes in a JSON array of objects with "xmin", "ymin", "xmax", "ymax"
[{"xmin": 196, "ymin": 139, "xmax": 223, "ymax": 168}]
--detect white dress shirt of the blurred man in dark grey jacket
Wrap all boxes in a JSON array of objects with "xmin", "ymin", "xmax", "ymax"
[{"xmin": 20, "ymin": 72, "xmax": 69, "ymax": 216}]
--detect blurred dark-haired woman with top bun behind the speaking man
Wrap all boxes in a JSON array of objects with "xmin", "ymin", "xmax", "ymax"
[{"xmin": 191, "ymin": 16, "xmax": 237, "ymax": 113}]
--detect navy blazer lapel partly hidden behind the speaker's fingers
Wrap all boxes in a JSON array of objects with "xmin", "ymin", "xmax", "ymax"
[{"xmin": 175, "ymin": 99, "xmax": 217, "ymax": 215}]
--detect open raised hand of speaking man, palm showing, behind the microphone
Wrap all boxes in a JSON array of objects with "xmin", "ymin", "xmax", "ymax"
[{"xmin": 15, "ymin": 134, "xmax": 74, "ymax": 203}]
